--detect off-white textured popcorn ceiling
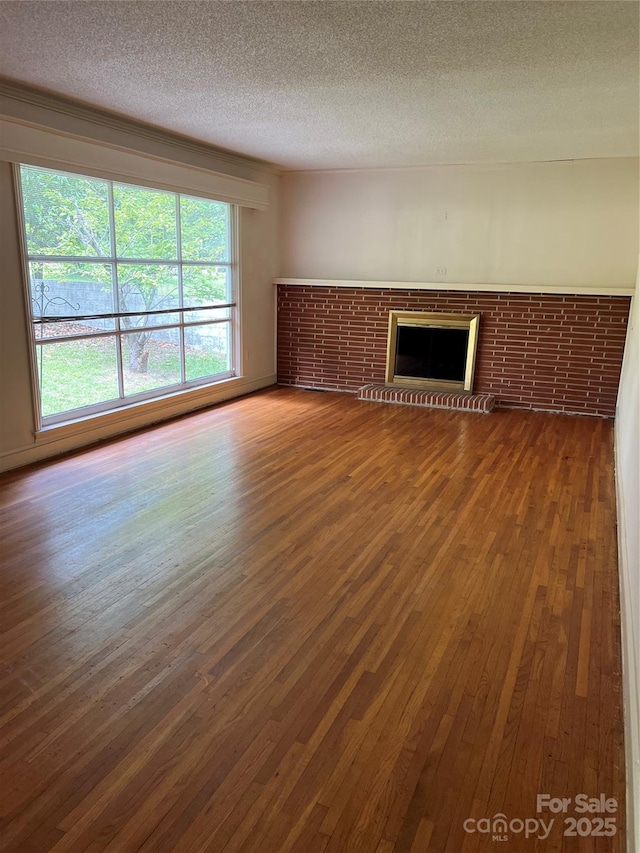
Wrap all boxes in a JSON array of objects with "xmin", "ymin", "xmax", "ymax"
[{"xmin": 0, "ymin": 0, "xmax": 639, "ymax": 169}]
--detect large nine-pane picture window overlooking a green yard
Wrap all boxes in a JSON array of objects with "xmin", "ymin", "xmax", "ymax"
[{"xmin": 19, "ymin": 166, "xmax": 235, "ymax": 425}]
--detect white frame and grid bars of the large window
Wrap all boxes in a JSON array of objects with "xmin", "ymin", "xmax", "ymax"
[{"xmin": 13, "ymin": 158, "xmax": 242, "ymax": 432}]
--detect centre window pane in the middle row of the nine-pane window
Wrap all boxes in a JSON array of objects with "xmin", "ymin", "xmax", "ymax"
[{"xmin": 118, "ymin": 264, "xmax": 180, "ymax": 316}]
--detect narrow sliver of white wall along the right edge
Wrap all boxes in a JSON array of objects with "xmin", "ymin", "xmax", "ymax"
[{"xmin": 615, "ymin": 259, "xmax": 640, "ymax": 850}]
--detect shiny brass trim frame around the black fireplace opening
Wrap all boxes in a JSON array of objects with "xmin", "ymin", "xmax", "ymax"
[{"xmin": 385, "ymin": 311, "xmax": 480, "ymax": 394}]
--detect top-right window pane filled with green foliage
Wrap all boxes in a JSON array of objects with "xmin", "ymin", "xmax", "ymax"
[{"xmin": 180, "ymin": 196, "xmax": 229, "ymax": 261}]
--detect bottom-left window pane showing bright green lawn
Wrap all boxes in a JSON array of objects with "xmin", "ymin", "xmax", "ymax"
[{"xmin": 36, "ymin": 335, "xmax": 118, "ymax": 417}]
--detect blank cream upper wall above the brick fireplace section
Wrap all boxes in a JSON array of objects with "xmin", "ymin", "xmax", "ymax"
[{"xmin": 280, "ymin": 159, "xmax": 638, "ymax": 288}]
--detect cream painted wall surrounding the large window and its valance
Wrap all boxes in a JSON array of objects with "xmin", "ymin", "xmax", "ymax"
[{"xmin": 0, "ymin": 98, "xmax": 280, "ymax": 470}]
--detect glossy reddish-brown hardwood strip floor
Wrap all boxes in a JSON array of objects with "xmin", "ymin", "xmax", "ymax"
[{"xmin": 0, "ymin": 389, "xmax": 624, "ymax": 853}]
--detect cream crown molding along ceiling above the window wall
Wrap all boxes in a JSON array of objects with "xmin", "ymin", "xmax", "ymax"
[{"xmin": 0, "ymin": 77, "xmax": 281, "ymax": 174}]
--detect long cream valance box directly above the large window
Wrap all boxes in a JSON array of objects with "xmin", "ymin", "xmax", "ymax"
[{"xmin": 0, "ymin": 118, "xmax": 269, "ymax": 210}]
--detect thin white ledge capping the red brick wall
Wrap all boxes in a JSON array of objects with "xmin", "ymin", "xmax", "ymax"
[{"xmin": 273, "ymin": 278, "xmax": 635, "ymax": 296}]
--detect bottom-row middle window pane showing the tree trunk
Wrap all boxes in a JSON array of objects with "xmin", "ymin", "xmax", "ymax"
[{"xmin": 122, "ymin": 329, "xmax": 182, "ymax": 397}]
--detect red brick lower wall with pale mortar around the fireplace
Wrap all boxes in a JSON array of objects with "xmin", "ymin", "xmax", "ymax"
[{"xmin": 278, "ymin": 285, "xmax": 630, "ymax": 416}]
